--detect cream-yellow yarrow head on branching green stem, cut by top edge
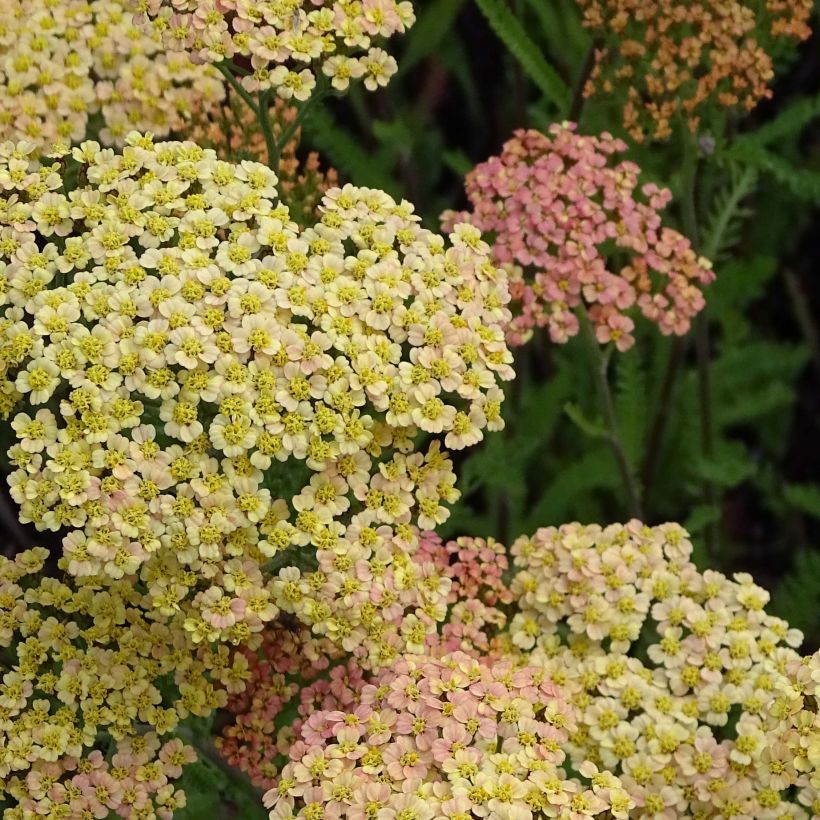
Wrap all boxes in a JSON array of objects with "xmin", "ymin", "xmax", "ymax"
[{"xmin": 135, "ymin": 0, "xmax": 415, "ymax": 100}]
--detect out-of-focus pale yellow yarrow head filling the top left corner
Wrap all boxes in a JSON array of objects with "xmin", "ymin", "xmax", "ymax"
[{"xmin": 0, "ymin": 0, "xmax": 224, "ymax": 147}]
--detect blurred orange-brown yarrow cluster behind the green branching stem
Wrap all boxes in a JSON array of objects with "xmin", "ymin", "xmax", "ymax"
[{"xmin": 186, "ymin": 95, "xmax": 339, "ymax": 224}]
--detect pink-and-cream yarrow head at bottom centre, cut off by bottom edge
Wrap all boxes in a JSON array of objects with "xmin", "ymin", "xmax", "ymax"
[{"xmin": 265, "ymin": 652, "xmax": 630, "ymax": 820}]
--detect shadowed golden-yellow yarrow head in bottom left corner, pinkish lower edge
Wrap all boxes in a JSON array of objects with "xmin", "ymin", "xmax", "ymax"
[{"xmin": 0, "ymin": 548, "xmax": 226, "ymax": 820}]
